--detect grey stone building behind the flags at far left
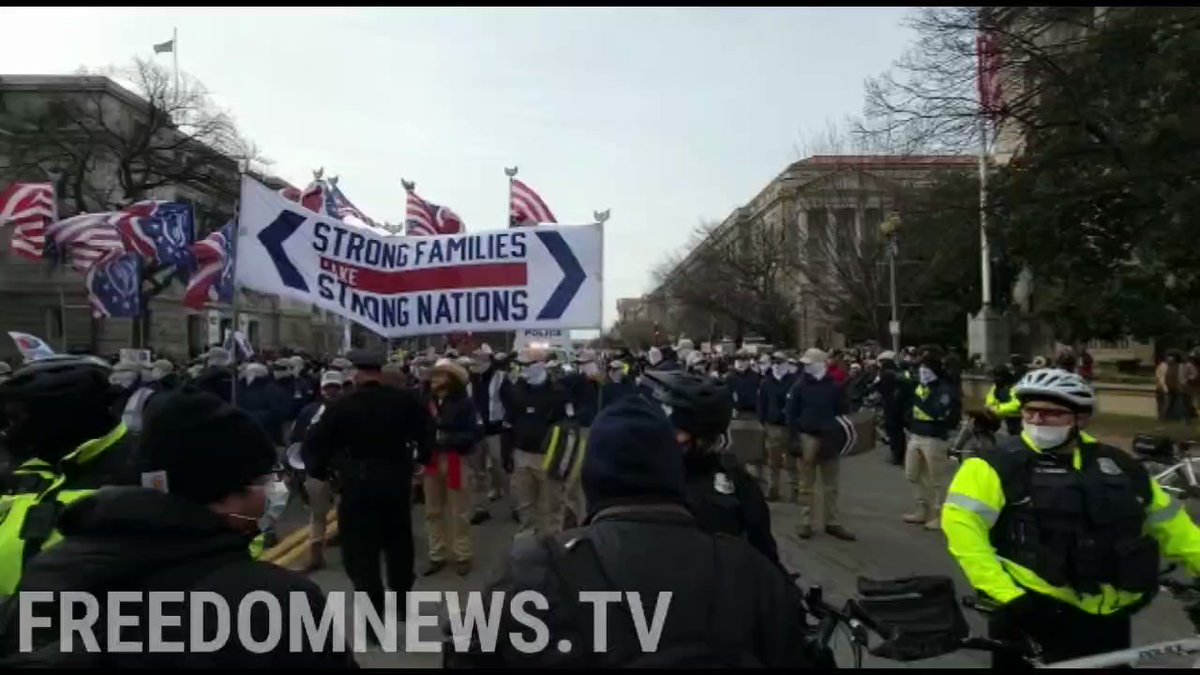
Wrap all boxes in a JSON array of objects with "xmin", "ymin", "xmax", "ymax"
[{"xmin": 0, "ymin": 76, "xmax": 342, "ymax": 360}]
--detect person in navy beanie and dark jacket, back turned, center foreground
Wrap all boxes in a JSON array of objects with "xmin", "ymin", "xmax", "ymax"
[{"xmin": 444, "ymin": 396, "xmax": 812, "ymax": 668}]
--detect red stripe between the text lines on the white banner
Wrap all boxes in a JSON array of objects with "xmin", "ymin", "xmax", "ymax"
[{"xmin": 320, "ymin": 258, "xmax": 529, "ymax": 295}]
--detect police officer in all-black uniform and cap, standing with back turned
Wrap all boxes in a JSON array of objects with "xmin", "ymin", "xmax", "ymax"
[{"xmin": 301, "ymin": 350, "xmax": 432, "ymax": 615}]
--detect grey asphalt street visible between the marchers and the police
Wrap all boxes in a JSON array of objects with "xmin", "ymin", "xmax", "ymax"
[{"xmin": 302, "ymin": 452, "xmax": 1192, "ymax": 668}]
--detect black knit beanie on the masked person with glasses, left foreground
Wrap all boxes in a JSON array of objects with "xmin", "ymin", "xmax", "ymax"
[{"xmin": 136, "ymin": 387, "xmax": 276, "ymax": 504}]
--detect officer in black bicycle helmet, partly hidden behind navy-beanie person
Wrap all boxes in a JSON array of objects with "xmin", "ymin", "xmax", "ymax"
[{"xmin": 646, "ymin": 371, "xmax": 780, "ymax": 565}]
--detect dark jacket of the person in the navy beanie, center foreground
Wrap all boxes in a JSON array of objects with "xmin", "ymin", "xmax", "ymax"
[{"xmin": 446, "ymin": 504, "xmax": 810, "ymax": 668}]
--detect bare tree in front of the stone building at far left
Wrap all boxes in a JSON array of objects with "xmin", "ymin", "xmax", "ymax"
[{"xmin": 0, "ymin": 59, "xmax": 264, "ymax": 215}]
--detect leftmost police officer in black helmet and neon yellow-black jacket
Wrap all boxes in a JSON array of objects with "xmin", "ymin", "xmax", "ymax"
[{"xmin": 0, "ymin": 356, "xmax": 140, "ymax": 596}]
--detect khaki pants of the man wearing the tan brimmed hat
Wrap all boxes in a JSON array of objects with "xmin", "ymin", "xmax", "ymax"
[{"xmin": 424, "ymin": 453, "xmax": 470, "ymax": 562}]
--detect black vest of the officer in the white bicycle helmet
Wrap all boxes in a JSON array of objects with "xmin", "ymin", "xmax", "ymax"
[{"xmin": 979, "ymin": 437, "xmax": 1159, "ymax": 596}]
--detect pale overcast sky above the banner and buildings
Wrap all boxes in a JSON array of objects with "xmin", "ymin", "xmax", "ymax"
[{"xmin": 0, "ymin": 7, "xmax": 912, "ymax": 324}]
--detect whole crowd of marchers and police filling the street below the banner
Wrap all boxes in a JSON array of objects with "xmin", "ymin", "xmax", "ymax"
[{"xmin": 0, "ymin": 333, "xmax": 1200, "ymax": 668}]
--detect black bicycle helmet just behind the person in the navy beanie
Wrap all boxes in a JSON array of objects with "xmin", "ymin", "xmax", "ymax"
[{"xmin": 642, "ymin": 370, "xmax": 733, "ymax": 440}]
